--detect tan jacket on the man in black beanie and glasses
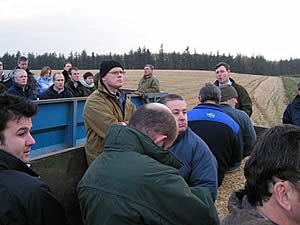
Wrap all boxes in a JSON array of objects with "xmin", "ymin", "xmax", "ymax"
[{"xmin": 83, "ymin": 82, "xmax": 136, "ymax": 165}]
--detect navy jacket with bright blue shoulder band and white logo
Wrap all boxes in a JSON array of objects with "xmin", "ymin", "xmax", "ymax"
[{"xmin": 188, "ymin": 104, "xmax": 242, "ymax": 186}]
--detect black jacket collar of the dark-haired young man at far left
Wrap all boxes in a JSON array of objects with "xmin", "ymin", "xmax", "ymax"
[{"xmin": 0, "ymin": 150, "xmax": 38, "ymax": 177}]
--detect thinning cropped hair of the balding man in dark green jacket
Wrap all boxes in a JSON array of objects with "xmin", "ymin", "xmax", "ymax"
[{"xmin": 128, "ymin": 103, "xmax": 177, "ymax": 140}]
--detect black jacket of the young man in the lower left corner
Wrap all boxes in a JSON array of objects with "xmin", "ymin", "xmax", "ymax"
[{"xmin": 0, "ymin": 150, "xmax": 68, "ymax": 225}]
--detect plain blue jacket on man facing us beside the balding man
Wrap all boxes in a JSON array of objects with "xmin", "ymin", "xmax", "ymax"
[{"xmin": 170, "ymin": 128, "xmax": 218, "ymax": 200}]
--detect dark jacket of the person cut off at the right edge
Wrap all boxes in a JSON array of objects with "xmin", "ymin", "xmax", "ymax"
[{"xmin": 282, "ymin": 95, "xmax": 300, "ymax": 126}]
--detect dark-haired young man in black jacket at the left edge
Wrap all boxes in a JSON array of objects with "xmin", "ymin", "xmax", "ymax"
[{"xmin": 0, "ymin": 94, "xmax": 68, "ymax": 225}]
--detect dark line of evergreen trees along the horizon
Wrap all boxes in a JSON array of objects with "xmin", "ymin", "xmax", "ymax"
[{"xmin": 0, "ymin": 45, "xmax": 300, "ymax": 75}]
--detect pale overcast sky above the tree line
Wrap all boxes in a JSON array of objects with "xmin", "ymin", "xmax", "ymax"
[{"xmin": 0, "ymin": 0, "xmax": 300, "ymax": 60}]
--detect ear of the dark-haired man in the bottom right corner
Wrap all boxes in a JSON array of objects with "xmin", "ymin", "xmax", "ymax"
[{"xmin": 273, "ymin": 181, "xmax": 292, "ymax": 211}]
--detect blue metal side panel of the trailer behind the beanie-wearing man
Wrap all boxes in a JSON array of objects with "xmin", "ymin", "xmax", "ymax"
[{"xmin": 30, "ymin": 93, "xmax": 166, "ymax": 158}]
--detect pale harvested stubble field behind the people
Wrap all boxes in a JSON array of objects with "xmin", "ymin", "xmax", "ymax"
[{"xmin": 124, "ymin": 70, "xmax": 285, "ymax": 127}]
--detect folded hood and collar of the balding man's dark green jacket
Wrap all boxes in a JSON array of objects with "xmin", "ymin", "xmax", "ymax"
[{"xmin": 104, "ymin": 124, "xmax": 182, "ymax": 169}]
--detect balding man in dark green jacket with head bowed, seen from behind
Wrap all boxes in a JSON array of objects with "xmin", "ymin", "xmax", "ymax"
[{"xmin": 78, "ymin": 103, "xmax": 219, "ymax": 225}]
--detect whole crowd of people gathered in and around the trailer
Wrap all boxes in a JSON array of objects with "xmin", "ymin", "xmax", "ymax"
[{"xmin": 0, "ymin": 57, "xmax": 300, "ymax": 225}]
